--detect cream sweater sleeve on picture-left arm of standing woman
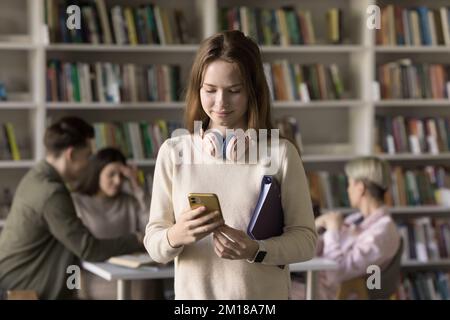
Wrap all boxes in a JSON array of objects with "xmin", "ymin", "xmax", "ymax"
[{"xmin": 144, "ymin": 140, "xmax": 183, "ymax": 263}]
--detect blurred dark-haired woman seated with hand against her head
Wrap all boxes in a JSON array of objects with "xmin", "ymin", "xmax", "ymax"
[{"xmin": 72, "ymin": 148, "xmax": 155, "ymax": 299}]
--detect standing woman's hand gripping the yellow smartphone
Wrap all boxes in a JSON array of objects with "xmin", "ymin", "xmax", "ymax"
[{"xmin": 167, "ymin": 207, "xmax": 224, "ymax": 248}]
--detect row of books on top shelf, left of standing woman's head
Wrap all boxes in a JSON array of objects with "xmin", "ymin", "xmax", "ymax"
[{"xmin": 45, "ymin": 0, "xmax": 193, "ymax": 45}]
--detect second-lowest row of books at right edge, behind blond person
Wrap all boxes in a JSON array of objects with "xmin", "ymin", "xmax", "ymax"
[{"xmin": 398, "ymin": 217, "xmax": 450, "ymax": 262}]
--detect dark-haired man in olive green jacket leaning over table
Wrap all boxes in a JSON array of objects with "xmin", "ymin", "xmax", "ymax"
[{"xmin": 0, "ymin": 117, "xmax": 144, "ymax": 299}]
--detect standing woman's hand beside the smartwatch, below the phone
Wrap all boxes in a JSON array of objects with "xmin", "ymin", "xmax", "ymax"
[{"xmin": 213, "ymin": 225, "xmax": 259, "ymax": 260}]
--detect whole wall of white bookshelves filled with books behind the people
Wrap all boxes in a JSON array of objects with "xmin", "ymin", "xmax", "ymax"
[{"xmin": 0, "ymin": 0, "xmax": 450, "ymax": 299}]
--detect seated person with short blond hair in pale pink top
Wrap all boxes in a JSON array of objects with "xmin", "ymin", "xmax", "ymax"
[{"xmin": 291, "ymin": 157, "xmax": 400, "ymax": 299}]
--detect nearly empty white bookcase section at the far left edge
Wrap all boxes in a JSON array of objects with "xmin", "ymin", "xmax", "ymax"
[{"xmin": 0, "ymin": 0, "xmax": 45, "ymax": 184}]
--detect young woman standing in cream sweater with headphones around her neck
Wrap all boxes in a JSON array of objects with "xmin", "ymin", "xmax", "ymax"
[{"xmin": 144, "ymin": 31, "xmax": 317, "ymax": 299}]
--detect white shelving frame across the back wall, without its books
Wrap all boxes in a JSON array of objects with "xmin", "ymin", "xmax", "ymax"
[{"xmin": 0, "ymin": 0, "xmax": 450, "ymax": 298}]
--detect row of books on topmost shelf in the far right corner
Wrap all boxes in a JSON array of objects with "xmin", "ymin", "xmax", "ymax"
[{"xmin": 376, "ymin": 4, "xmax": 450, "ymax": 46}]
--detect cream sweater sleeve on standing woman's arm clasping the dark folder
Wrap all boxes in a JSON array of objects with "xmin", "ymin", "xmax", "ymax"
[{"xmin": 261, "ymin": 141, "xmax": 317, "ymax": 265}]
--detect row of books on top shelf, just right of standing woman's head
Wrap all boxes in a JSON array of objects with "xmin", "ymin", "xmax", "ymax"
[{"xmin": 219, "ymin": 6, "xmax": 343, "ymax": 46}]
